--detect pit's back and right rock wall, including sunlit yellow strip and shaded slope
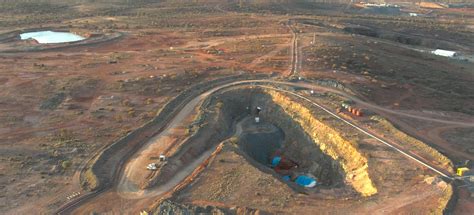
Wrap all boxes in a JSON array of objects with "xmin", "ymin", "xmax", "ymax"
[{"xmin": 214, "ymin": 89, "xmax": 377, "ymax": 196}]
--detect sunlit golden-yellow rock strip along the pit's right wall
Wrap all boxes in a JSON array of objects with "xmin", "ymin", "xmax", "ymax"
[{"xmin": 266, "ymin": 90, "xmax": 377, "ymax": 196}]
